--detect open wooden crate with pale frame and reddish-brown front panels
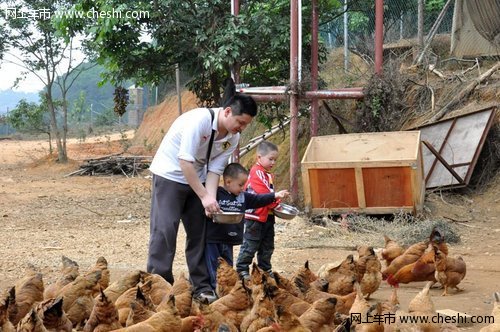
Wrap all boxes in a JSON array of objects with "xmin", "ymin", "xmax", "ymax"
[{"xmin": 302, "ymin": 131, "xmax": 425, "ymax": 214}]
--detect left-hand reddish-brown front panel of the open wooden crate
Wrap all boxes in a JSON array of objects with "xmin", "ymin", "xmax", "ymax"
[{"xmin": 309, "ymin": 168, "xmax": 358, "ymax": 209}]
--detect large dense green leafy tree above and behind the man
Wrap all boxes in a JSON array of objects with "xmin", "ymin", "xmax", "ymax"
[{"xmin": 57, "ymin": 0, "xmax": 337, "ymax": 105}]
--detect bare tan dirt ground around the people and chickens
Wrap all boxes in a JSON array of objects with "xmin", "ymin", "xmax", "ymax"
[{"xmin": 0, "ymin": 134, "xmax": 500, "ymax": 331}]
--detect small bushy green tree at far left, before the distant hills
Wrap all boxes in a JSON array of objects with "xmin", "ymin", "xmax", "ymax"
[{"xmin": 6, "ymin": 99, "xmax": 52, "ymax": 153}]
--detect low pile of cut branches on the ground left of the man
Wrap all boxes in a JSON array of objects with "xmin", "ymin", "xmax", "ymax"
[{"xmin": 67, "ymin": 156, "xmax": 152, "ymax": 177}]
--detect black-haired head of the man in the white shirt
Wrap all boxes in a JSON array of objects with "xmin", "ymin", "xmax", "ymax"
[{"xmin": 222, "ymin": 94, "xmax": 257, "ymax": 134}]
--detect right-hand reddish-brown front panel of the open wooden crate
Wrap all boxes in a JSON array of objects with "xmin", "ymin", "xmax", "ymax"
[{"xmin": 363, "ymin": 167, "xmax": 413, "ymax": 207}]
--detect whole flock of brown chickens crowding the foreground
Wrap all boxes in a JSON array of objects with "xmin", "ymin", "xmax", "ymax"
[{"xmin": 0, "ymin": 229, "xmax": 500, "ymax": 332}]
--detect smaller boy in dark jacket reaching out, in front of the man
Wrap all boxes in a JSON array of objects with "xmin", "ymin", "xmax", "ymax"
[{"xmin": 205, "ymin": 163, "xmax": 288, "ymax": 289}]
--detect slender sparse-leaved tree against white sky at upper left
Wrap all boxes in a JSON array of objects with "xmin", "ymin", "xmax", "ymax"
[{"xmin": 0, "ymin": 0, "xmax": 88, "ymax": 162}]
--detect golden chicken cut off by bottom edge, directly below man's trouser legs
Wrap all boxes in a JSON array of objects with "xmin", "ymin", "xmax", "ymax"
[{"xmin": 116, "ymin": 295, "xmax": 182, "ymax": 332}]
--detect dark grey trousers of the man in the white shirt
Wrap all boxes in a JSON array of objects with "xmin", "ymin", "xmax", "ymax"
[{"xmin": 147, "ymin": 175, "xmax": 212, "ymax": 295}]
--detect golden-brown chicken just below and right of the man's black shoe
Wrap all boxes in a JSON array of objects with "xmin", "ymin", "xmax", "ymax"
[{"xmin": 210, "ymin": 280, "xmax": 252, "ymax": 326}]
